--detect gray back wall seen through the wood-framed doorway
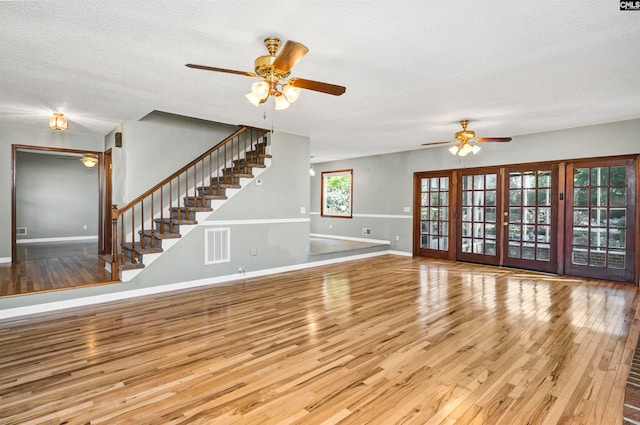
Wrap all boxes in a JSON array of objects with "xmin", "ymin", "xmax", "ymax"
[{"xmin": 16, "ymin": 151, "xmax": 100, "ymax": 240}]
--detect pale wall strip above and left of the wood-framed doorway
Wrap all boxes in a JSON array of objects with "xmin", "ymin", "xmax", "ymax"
[{"xmin": 0, "ymin": 121, "xmax": 104, "ymax": 262}]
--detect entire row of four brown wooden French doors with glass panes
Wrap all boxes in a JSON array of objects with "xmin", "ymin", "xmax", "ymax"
[{"xmin": 414, "ymin": 156, "xmax": 640, "ymax": 282}]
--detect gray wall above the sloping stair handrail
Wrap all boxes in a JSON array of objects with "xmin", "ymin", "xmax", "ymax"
[{"xmin": 114, "ymin": 112, "xmax": 238, "ymax": 207}]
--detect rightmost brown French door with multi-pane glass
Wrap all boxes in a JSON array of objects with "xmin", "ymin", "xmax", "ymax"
[{"xmin": 565, "ymin": 161, "xmax": 635, "ymax": 281}]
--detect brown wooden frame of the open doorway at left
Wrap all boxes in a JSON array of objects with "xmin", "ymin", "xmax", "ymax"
[{"xmin": 11, "ymin": 144, "xmax": 104, "ymax": 263}]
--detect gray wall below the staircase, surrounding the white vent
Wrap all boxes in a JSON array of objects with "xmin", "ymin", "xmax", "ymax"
[{"xmin": 127, "ymin": 133, "xmax": 309, "ymax": 286}]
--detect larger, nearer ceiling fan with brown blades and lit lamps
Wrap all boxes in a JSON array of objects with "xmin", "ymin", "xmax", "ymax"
[{"xmin": 186, "ymin": 37, "xmax": 346, "ymax": 110}]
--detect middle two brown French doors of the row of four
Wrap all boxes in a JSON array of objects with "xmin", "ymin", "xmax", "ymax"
[{"xmin": 456, "ymin": 165, "xmax": 558, "ymax": 271}]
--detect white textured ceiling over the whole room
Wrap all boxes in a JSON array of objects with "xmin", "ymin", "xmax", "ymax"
[{"xmin": 0, "ymin": 0, "xmax": 640, "ymax": 162}]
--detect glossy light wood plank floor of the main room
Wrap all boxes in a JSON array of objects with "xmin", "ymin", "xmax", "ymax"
[{"xmin": 0, "ymin": 255, "xmax": 640, "ymax": 425}]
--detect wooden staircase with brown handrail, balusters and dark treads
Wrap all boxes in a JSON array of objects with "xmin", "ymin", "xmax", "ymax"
[{"xmin": 111, "ymin": 126, "xmax": 269, "ymax": 281}]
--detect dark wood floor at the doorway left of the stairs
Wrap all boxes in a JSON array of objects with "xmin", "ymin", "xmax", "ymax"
[{"xmin": 0, "ymin": 241, "xmax": 111, "ymax": 296}]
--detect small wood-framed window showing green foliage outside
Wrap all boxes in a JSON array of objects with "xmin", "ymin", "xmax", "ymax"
[{"xmin": 321, "ymin": 170, "xmax": 353, "ymax": 218}]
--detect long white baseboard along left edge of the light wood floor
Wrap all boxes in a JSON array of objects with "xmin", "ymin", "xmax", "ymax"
[{"xmin": 0, "ymin": 251, "xmax": 410, "ymax": 319}]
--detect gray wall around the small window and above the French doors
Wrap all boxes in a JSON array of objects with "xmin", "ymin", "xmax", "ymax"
[{"xmin": 310, "ymin": 119, "xmax": 640, "ymax": 252}]
